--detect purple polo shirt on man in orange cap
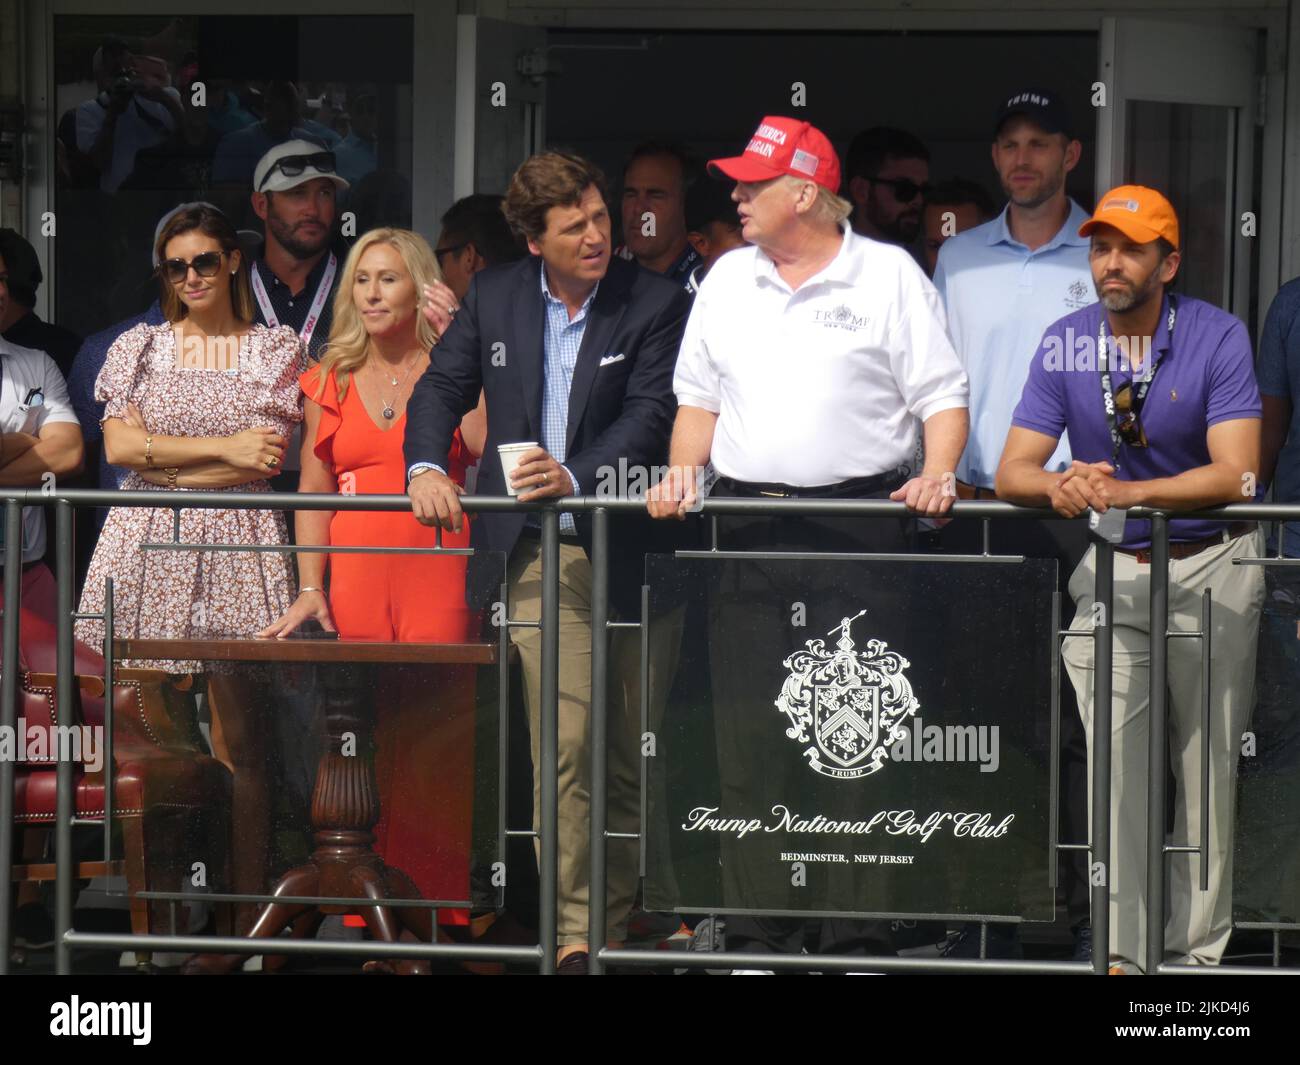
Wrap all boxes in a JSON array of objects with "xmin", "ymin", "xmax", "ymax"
[{"xmin": 1011, "ymin": 296, "xmax": 1261, "ymax": 550}]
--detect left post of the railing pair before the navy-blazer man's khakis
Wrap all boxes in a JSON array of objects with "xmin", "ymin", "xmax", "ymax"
[{"xmin": 538, "ymin": 507, "xmax": 560, "ymax": 974}]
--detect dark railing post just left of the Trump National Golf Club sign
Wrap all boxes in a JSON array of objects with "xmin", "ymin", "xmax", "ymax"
[{"xmin": 586, "ymin": 507, "xmax": 610, "ymax": 975}]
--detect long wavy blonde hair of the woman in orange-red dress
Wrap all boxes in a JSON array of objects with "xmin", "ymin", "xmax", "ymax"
[{"xmin": 313, "ymin": 229, "xmax": 442, "ymax": 402}]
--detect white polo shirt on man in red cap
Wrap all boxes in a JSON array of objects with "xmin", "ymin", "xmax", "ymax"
[{"xmin": 673, "ymin": 226, "xmax": 967, "ymax": 486}]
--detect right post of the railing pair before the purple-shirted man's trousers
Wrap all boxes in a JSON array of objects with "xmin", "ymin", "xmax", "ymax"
[{"xmin": 1154, "ymin": 514, "xmax": 1169, "ymax": 973}]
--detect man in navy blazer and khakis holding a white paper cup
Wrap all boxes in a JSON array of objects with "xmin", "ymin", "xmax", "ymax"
[{"xmin": 404, "ymin": 152, "xmax": 690, "ymax": 973}]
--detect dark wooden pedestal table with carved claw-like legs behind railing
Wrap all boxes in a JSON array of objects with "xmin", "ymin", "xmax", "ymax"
[{"xmin": 113, "ymin": 638, "xmax": 498, "ymax": 973}]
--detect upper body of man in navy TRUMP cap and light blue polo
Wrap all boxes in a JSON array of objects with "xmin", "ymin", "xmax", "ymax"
[{"xmin": 935, "ymin": 90, "xmax": 1093, "ymax": 498}]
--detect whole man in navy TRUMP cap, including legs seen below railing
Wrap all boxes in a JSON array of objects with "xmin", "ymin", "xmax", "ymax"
[{"xmin": 933, "ymin": 88, "xmax": 1096, "ymax": 961}]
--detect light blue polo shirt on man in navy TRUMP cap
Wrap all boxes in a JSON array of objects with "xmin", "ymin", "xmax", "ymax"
[{"xmin": 935, "ymin": 200, "xmax": 1097, "ymax": 488}]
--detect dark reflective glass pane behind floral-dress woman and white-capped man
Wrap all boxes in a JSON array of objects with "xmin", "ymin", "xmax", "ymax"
[{"xmin": 52, "ymin": 16, "xmax": 412, "ymax": 335}]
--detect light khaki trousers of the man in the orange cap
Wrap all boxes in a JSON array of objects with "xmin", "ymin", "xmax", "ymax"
[{"xmin": 1062, "ymin": 531, "xmax": 1264, "ymax": 967}]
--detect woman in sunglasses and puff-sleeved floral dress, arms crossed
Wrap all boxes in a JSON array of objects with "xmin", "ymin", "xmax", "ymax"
[{"xmin": 77, "ymin": 204, "xmax": 304, "ymax": 926}]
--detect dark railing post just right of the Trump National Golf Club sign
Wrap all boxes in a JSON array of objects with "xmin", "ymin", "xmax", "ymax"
[{"xmin": 1088, "ymin": 540, "xmax": 1115, "ymax": 975}]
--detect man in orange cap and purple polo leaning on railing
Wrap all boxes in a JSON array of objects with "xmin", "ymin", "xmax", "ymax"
[{"xmin": 997, "ymin": 185, "xmax": 1264, "ymax": 973}]
